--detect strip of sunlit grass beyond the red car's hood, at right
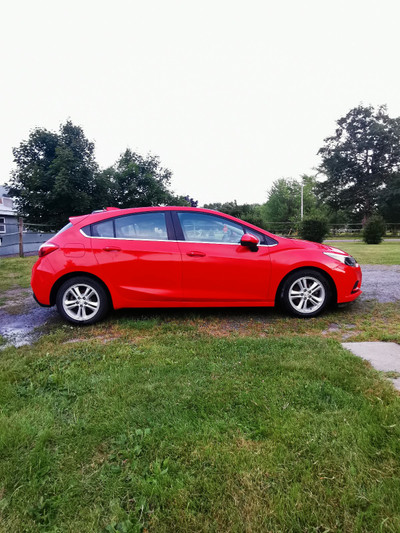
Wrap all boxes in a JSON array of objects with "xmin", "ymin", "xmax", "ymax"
[{"xmin": 327, "ymin": 241, "xmax": 400, "ymax": 266}]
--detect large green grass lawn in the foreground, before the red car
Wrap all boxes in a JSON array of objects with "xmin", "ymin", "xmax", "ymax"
[{"xmin": 0, "ymin": 251, "xmax": 400, "ymax": 533}]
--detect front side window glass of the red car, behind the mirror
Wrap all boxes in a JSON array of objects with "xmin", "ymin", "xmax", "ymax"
[{"xmin": 178, "ymin": 212, "xmax": 244, "ymax": 244}]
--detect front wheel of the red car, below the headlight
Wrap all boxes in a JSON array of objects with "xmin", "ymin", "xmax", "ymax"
[{"xmin": 281, "ymin": 269, "xmax": 332, "ymax": 318}]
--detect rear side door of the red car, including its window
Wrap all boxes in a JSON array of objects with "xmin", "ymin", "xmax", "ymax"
[{"xmin": 90, "ymin": 211, "xmax": 182, "ymax": 306}]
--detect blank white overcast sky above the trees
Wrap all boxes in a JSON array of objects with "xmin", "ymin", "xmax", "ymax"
[{"xmin": 0, "ymin": 0, "xmax": 400, "ymax": 204}]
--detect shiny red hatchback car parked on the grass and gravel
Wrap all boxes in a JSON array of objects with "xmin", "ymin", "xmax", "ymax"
[{"xmin": 31, "ymin": 207, "xmax": 361, "ymax": 324}]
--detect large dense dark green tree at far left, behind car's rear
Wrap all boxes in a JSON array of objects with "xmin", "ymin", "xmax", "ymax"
[{"xmin": 8, "ymin": 121, "xmax": 102, "ymax": 228}]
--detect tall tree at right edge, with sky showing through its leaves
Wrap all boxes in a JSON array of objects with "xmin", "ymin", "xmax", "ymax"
[{"xmin": 318, "ymin": 105, "xmax": 400, "ymax": 220}]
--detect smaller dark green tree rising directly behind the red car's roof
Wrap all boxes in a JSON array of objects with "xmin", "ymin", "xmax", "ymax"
[{"xmin": 102, "ymin": 148, "xmax": 176, "ymax": 208}]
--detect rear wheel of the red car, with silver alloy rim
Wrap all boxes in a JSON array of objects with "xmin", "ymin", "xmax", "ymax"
[{"xmin": 56, "ymin": 276, "xmax": 109, "ymax": 326}]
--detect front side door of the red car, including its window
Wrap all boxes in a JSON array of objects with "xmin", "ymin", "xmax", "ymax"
[{"xmin": 173, "ymin": 210, "xmax": 270, "ymax": 305}]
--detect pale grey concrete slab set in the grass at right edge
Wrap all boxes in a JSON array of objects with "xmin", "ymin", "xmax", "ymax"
[{"xmin": 342, "ymin": 342, "xmax": 400, "ymax": 390}]
